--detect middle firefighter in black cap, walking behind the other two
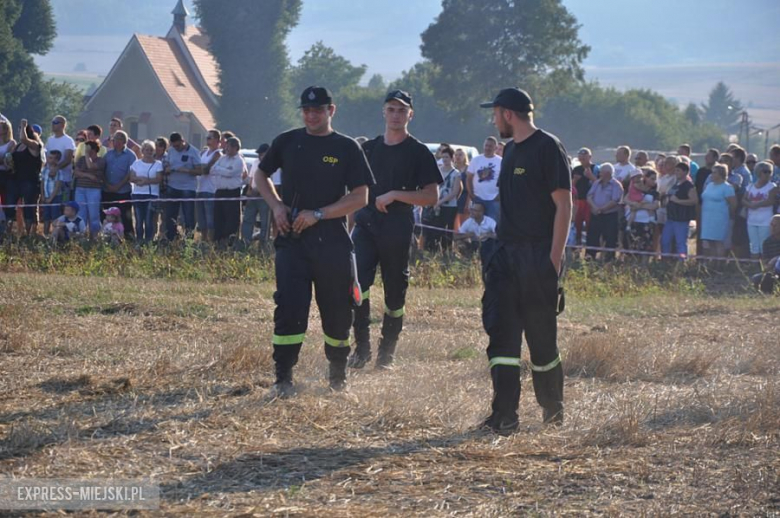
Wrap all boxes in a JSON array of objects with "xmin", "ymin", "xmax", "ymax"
[{"xmin": 349, "ymin": 90, "xmax": 442, "ymax": 369}]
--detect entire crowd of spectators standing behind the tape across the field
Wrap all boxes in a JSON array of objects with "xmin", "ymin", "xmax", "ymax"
[{"xmin": 0, "ymin": 111, "xmax": 780, "ymax": 292}]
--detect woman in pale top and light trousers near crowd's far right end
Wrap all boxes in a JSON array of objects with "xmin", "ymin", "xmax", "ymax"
[{"xmin": 742, "ymin": 162, "xmax": 777, "ymax": 259}]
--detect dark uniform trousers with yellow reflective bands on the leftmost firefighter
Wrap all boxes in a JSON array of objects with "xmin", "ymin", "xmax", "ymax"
[{"xmin": 273, "ymin": 234, "xmax": 352, "ymax": 376}]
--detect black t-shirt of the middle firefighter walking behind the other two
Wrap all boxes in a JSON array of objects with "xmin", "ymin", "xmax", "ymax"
[{"xmin": 363, "ymin": 135, "xmax": 443, "ymax": 214}]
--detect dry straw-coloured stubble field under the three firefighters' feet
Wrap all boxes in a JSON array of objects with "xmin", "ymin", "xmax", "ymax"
[{"xmin": 0, "ymin": 274, "xmax": 780, "ymax": 517}]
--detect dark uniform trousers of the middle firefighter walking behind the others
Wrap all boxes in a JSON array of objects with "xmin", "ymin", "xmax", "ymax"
[{"xmin": 352, "ymin": 207, "xmax": 414, "ymax": 354}]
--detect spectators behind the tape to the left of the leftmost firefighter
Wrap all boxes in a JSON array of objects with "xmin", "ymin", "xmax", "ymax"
[{"xmin": 0, "ymin": 116, "xmax": 258, "ymax": 245}]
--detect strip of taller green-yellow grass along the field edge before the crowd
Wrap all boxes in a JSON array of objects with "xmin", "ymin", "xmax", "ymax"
[{"xmin": 0, "ymin": 239, "xmax": 753, "ymax": 300}]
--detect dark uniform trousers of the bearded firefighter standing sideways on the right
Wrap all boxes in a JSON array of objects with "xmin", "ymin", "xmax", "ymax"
[{"xmin": 482, "ymin": 242, "xmax": 563, "ymax": 416}]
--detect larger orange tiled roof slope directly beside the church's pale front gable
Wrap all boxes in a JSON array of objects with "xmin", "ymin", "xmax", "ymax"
[{"xmin": 135, "ymin": 34, "xmax": 216, "ymax": 129}]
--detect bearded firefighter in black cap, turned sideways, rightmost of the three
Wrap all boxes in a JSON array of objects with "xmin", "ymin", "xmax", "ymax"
[{"xmin": 482, "ymin": 88, "xmax": 572, "ymax": 433}]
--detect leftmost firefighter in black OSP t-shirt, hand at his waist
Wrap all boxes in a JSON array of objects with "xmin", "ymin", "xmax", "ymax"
[{"xmin": 255, "ymin": 86, "xmax": 373, "ymax": 398}]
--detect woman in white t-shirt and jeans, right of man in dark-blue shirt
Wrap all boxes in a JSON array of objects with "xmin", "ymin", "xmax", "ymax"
[{"xmin": 130, "ymin": 140, "xmax": 163, "ymax": 242}]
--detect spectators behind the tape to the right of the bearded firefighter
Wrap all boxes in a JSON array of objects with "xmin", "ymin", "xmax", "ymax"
[{"xmin": 572, "ymin": 144, "xmax": 780, "ymax": 270}]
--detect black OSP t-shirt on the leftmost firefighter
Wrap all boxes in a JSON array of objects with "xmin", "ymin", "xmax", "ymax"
[{"xmin": 260, "ymin": 128, "xmax": 373, "ymax": 236}]
